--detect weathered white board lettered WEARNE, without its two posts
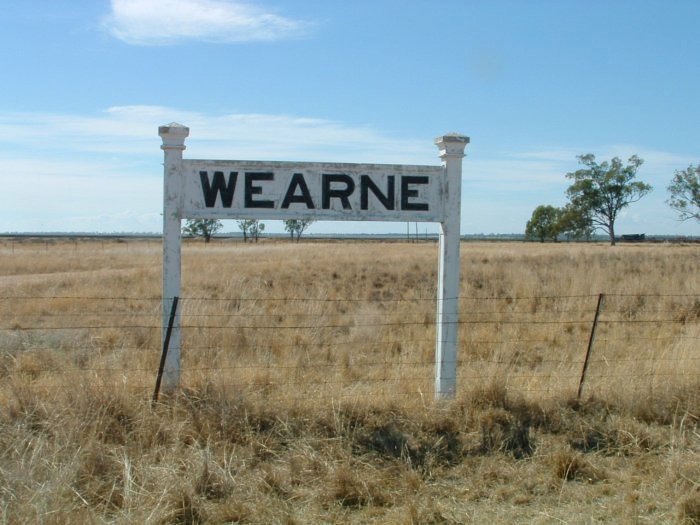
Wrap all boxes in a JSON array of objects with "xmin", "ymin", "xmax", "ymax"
[{"xmin": 182, "ymin": 160, "xmax": 447, "ymax": 222}]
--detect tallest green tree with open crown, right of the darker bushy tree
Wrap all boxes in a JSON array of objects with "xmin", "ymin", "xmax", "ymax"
[{"xmin": 566, "ymin": 153, "xmax": 651, "ymax": 246}]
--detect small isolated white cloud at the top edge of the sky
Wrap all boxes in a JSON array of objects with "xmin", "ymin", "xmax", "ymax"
[{"xmin": 104, "ymin": 0, "xmax": 312, "ymax": 45}]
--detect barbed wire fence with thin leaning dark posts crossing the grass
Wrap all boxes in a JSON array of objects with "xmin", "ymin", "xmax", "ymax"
[{"xmin": 0, "ymin": 290, "xmax": 700, "ymax": 402}]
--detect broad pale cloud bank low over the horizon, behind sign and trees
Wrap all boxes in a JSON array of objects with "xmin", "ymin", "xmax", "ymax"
[{"xmin": 0, "ymin": 106, "xmax": 698, "ymax": 235}]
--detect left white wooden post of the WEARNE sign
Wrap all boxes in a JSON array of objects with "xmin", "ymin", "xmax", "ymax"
[{"xmin": 158, "ymin": 123, "xmax": 190, "ymax": 392}]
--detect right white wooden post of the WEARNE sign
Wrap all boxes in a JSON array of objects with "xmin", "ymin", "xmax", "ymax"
[{"xmin": 435, "ymin": 134, "xmax": 469, "ymax": 399}]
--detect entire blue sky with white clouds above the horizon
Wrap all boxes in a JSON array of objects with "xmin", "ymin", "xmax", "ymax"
[{"xmin": 0, "ymin": 0, "xmax": 700, "ymax": 235}]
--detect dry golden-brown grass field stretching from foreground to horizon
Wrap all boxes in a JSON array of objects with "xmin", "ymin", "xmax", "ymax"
[{"xmin": 0, "ymin": 239, "xmax": 700, "ymax": 524}]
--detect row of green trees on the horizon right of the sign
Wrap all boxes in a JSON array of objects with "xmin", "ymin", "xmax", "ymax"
[{"xmin": 525, "ymin": 153, "xmax": 700, "ymax": 245}]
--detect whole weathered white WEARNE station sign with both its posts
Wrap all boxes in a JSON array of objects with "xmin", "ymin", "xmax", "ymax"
[{"xmin": 158, "ymin": 123, "xmax": 469, "ymax": 398}]
